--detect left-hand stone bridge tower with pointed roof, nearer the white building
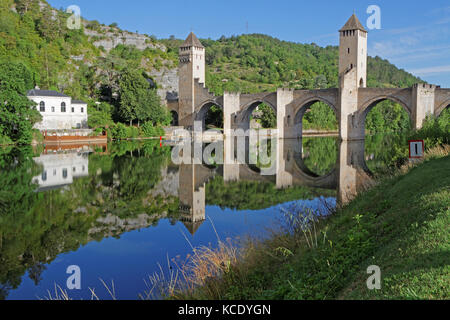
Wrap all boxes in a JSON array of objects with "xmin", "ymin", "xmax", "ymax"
[{"xmin": 178, "ymin": 32, "xmax": 205, "ymax": 128}]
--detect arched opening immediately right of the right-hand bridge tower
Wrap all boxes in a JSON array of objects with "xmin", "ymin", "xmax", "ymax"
[{"xmin": 363, "ymin": 97, "xmax": 412, "ymax": 135}]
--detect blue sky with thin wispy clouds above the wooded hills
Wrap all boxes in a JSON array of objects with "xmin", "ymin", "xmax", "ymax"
[{"xmin": 48, "ymin": 0, "xmax": 450, "ymax": 88}]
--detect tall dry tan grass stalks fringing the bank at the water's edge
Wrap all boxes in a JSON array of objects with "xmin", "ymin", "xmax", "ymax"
[{"xmin": 146, "ymin": 199, "xmax": 335, "ymax": 300}]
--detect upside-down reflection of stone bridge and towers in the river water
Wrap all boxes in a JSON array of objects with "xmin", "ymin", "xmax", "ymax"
[{"xmin": 178, "ymin": 139, "xmax": 373, "ymax": 234}]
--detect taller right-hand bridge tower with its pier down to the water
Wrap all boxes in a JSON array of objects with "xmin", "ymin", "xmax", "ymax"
[{"xmin": 339, "ymin": 14, "xmax": 367, "ymax": 140}]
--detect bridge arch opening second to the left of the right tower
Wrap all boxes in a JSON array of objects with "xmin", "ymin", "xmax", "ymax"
[{"xmin": 240, "ymin": 101, "xmax": 277, "ymax": 129}]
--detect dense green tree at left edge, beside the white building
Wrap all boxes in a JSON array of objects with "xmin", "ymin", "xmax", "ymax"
[{"xmin": 0, "ymin": 63, "xmax": 42, "ymax": 144}]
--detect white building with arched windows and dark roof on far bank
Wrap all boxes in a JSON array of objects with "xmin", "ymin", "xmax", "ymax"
[{"xmin": 27, "ymin": 89, "xmax": 88, "ymax": 131}]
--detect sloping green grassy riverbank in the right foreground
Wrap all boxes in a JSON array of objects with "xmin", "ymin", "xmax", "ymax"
[{"xmin": 171, "ymin": 147, "xmax": 450, "ymax": 300}]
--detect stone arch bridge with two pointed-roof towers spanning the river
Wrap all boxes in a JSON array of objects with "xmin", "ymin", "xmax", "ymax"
[{"xmin": 167, "ymin": 15, "xmax": 450, "ymax": 140}]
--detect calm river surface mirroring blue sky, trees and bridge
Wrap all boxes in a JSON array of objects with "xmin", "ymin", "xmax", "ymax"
[{"xmin": 0, "ymin": 137, "xmax": 408, "ymax": 300}]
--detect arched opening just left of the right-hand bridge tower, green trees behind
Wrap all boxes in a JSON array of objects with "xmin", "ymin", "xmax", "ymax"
[{"xmin": 294, "ymin": 99, "xmax": 338, "ymax": 136}]
